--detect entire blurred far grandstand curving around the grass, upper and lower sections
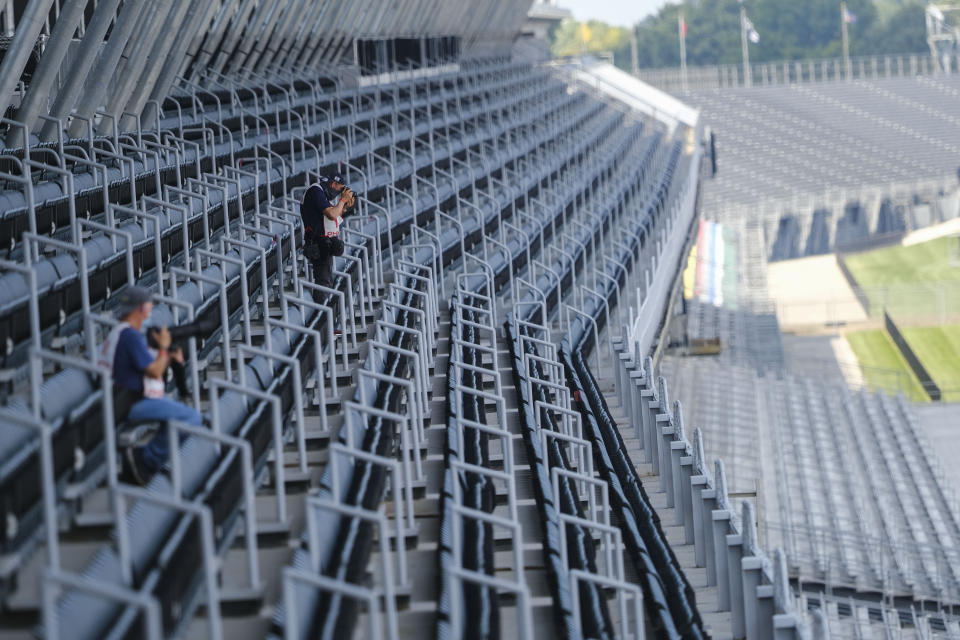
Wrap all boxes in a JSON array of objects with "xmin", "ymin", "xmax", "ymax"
[{"xmin": 648, "ymin": 37, "xmax": 960, "ymax": 638}]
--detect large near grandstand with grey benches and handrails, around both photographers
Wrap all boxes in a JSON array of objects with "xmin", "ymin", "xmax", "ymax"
[{"xmin": 0, "ymin": 0, "xmax": 936, "ymax": 639}]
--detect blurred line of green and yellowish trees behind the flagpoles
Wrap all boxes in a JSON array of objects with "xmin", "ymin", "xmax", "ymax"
[{"xmin": 551, "ymin": 0, "xmax": 928, "ymax": 70}]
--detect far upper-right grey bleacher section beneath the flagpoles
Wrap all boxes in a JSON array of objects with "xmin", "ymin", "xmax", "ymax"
[{"xmin": 682, "ymin": 74, "xmax": 960, "ymax": 260}]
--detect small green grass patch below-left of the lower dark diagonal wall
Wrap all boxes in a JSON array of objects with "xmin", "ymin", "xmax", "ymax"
[{"xmin": 847, "ymin": 329, "xmax": 930, "ymax": 402}]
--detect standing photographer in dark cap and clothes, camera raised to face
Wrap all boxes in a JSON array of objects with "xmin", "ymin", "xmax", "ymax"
[{"xmin": 300, "ymin": 173, "xmax": 354, "ymax": 302}]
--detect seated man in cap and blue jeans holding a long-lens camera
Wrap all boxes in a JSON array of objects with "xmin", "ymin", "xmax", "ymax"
[{"xmin": 100, "ymin": 286, "xmax": 203, "ymax": 485}]
